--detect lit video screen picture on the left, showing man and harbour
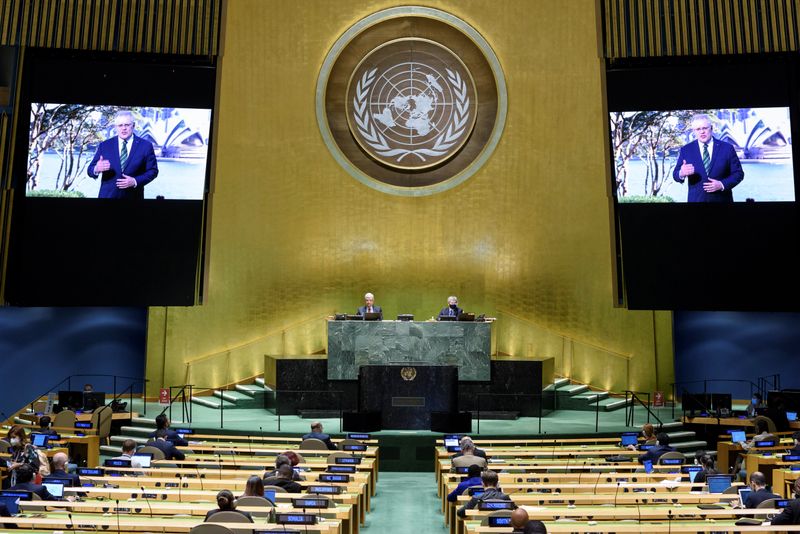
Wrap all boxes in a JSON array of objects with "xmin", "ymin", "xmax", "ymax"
[{"xmin": 25, "ymin": 103, "xmax": 211, "ymax": 200}]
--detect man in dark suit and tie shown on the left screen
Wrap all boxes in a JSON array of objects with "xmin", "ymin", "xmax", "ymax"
[{"xmin": 87, "ymin": 111, "xmax": 158, "ymax": 200}]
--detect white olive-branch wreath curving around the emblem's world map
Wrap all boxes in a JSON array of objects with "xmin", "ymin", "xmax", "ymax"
[{"xmin": 353, "ymin": 68, "xmax": 470, "ymax": 162}]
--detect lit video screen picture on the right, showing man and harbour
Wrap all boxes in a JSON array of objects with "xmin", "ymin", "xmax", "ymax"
[{"xmin": 609, "ymin": 106, "xmax": 795, "ymax": 203}]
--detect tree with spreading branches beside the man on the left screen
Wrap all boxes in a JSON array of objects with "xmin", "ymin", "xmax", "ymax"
[{"xmin": 27, "ymin": 104, "xmax": 116, "ymax": 191}]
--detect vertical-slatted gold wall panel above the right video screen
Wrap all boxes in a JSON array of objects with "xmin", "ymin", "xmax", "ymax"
[{"xmin": 602, "ymin": 0, "xmax": 800, "ymax": 58}]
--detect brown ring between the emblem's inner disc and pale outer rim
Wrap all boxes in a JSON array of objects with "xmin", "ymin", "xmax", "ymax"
[{"xmin": 324, "ymin": 14, "xmax": 498, "ymax": 192}]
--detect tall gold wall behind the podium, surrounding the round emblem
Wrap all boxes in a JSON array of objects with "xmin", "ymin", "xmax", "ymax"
[{"xmin": 147, "ymin": 0, "xmax": 673, "ymax": 398}]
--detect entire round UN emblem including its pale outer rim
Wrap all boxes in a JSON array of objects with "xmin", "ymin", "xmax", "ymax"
[{"xmin": 316, "ymin": 6, "xmax": 508, "ymax": 196}]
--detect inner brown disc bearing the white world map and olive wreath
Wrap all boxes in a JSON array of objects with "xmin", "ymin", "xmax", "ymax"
[{"xmin": 346, "ymin": 39, "xmax": 478, "ymax": 174}]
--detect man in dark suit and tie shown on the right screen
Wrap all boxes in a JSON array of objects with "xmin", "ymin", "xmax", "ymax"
[{"xmin": 672, "ymin": 115, "xmax": 744, "ymax": 202}]
